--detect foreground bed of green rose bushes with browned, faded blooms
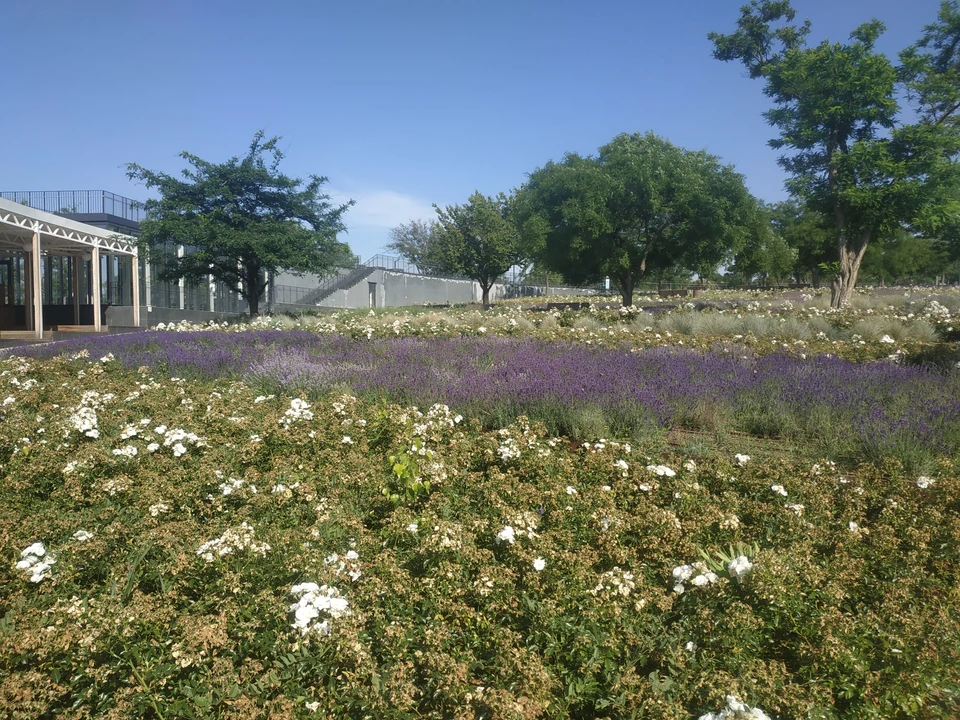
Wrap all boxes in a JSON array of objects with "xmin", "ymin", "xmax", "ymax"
[{"xmin": 0, "ymin": 358, "xmax": 960, "ymax": 720}]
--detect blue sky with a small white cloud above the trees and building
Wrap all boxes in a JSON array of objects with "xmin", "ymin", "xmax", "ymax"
[{"xmin": 0, "ymin": 0, "xmax": 939, "ymax": 258}]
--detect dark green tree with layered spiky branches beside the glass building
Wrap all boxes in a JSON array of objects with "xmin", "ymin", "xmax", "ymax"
[{"xmin": 127, "ymin": 131, "xmax": 353, "ymax": 315}]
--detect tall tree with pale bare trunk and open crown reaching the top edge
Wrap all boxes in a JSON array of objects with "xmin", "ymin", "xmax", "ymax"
[{"xmin": 709, "ymin": 0, "xmax": 950, "ymax": 307}]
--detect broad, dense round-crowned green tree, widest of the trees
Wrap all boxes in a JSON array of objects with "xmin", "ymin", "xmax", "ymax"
[{"xmin": 519, "ymin": 133, "xmax": 760, "ymax": 305}]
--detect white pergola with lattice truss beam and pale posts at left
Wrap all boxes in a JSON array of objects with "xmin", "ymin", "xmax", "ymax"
[{"xmin": 0, "ymin": 198, "xmax": 140, "ymax": 340}]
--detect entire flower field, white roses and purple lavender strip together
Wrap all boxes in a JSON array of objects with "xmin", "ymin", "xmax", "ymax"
[{"xmin": 0, "ymin": 290, "xmax": 960, "ymax": 719}]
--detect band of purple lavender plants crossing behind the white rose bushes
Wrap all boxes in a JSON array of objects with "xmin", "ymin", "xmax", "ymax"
[{"xmin": 20, "ymin": 330, "xmax": 960, "ymax": 464}]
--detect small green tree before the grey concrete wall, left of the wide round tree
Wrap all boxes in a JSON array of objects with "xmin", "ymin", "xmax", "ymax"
[{"xmin": 428, "ymin": 191, "xmax": 524, "ymax": 305}]
